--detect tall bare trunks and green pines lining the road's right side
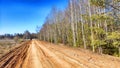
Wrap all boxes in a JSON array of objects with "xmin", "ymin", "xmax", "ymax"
[{"xmin": 37, "ymin": 0, "xmax": 120, "ymax": 56}]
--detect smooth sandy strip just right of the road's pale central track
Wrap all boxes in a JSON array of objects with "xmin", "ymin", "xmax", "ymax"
[{"xmin": 35, "ymin": 41, "xmax": 71, "ymax": 68}]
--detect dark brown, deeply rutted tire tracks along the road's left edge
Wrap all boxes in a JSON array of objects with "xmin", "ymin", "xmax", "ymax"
[{"xmin": 0, "ymin": 41, "xmax": 30, "ymax": 68}]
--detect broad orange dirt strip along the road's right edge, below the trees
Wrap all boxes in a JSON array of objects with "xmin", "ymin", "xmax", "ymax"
[{"xmin": 36, "ymin": 42, "xmax": 120, "ymax": 68}]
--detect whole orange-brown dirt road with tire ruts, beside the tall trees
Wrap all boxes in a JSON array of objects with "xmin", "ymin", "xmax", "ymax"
[{"xmin": 0, "ymin": 40, "xmax": 120, "ymax": 68}]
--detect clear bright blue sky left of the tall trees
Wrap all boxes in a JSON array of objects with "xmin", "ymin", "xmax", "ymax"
[{"xmin": 0, "ymin": 0, "xmax": 68, "ymax": 35}]
